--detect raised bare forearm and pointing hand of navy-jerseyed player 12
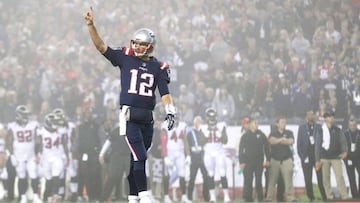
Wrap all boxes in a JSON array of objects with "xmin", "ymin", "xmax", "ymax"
[{"xmin": 84, "ymin": 7, "xmax": 107, "ymax": 54}]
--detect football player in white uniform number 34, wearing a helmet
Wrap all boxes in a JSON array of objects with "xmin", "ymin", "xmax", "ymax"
[{"xmin": 36, "ymin": 113, "xmax": 69, "ymax": 203}]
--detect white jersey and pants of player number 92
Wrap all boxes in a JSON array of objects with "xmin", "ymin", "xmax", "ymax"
[{"xmin": 8, "ymin": 121, "xmax": 39, "ymax": 179}]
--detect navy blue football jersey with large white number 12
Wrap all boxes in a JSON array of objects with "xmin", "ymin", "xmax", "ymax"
[{"xmin": 103, "ymin": 47, "xmax": 170, "ymax": 110}]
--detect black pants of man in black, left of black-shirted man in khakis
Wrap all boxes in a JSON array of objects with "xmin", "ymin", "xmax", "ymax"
[{"xmin": 243, "ymin": 163, "xmax": 264, "ymax": 202}]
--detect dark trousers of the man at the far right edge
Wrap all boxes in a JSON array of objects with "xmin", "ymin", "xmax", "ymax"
[{"xmin": 344, "ymin": 159, "xmax": 360, "ymax": 198}]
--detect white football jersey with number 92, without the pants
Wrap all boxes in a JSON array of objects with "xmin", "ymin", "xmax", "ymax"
[{"xmin": 8, "ymin": 121, "xmax": 39, "ymax": 160}]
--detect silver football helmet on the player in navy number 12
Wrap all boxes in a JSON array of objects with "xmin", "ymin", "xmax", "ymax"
[{"xmin": 130, "ymin": 28, "xmax": 156, "ymax": 57}]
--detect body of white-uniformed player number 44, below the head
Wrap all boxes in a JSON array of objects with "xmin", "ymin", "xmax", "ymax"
[{"xmin": 163, "ymin": 121, "xmax": 190, "ymax": 203}]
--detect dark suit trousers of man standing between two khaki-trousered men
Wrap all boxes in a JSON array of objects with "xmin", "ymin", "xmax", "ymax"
[{"xmin": 301, "ymin": 160, "xmax": 326, "ymax": 200}]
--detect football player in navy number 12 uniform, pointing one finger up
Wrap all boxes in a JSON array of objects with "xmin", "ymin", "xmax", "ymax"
[{"xmin": 84, "ymin": 7, "xmax": 176, "ymax": 203}]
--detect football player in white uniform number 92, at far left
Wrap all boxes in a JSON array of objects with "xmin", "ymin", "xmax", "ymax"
[{"xmin": 6, "ymin": 105, "xmax": 41, "ymax": 203}]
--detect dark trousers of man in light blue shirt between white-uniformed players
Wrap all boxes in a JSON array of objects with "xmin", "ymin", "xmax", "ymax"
[{"xmin": 188, "ymin": 154, "xmax": 209, "ymax": 200}]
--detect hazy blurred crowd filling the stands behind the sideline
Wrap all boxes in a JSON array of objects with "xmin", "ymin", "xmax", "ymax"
[{"xmin": 0, "ymin": 0, "xmax": 360, "ymax": 124}]
